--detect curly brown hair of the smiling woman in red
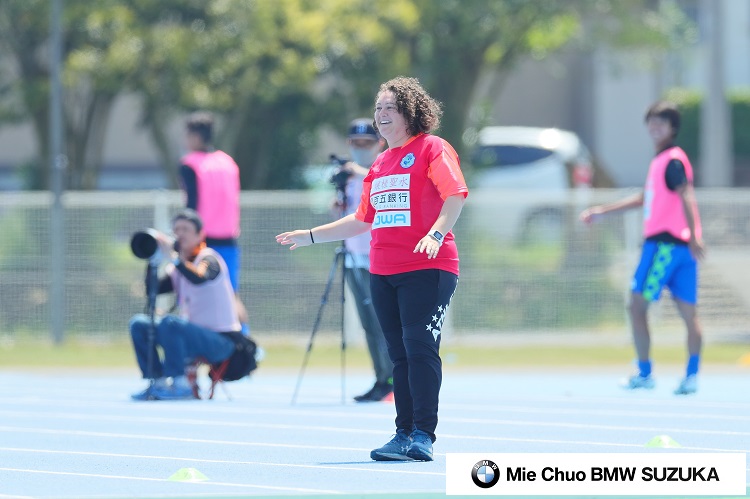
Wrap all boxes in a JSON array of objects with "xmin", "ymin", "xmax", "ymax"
[{"xmin": 373, "ymin": 76, "xmax": 443, "ymax": 136}]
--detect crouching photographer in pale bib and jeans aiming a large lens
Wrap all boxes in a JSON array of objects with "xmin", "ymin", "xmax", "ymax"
[{"xmin": 130, "ymin": 209, "xmax": 257, "ymax": 400}]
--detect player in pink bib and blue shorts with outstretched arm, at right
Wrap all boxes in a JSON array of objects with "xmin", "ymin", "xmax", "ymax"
[{"xmin": 581, "ymin": 101, "xmax": 705, "ymax": 395}]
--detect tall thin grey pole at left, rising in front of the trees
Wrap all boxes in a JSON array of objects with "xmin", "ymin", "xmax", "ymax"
[{"xmin": 49, "ymin": 0, "xmax": 68, "ymax": 344}]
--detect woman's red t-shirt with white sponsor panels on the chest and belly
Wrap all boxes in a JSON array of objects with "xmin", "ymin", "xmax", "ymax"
[{"xmin": 354, "ymin": 134, "xmax": 469, "ymax": 275}]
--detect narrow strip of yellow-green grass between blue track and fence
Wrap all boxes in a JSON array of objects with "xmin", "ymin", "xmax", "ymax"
[{"xmin": 0, "ymin": 338, "xmax": 750, "ymax": 369}]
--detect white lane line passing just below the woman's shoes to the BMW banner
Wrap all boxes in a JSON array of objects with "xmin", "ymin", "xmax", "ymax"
[{"xmin": 0, "ymin": 447, "xmax": 445, "ymax": 476}]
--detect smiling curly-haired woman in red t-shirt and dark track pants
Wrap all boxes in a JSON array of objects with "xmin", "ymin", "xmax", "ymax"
[{"xmin": 276, "ymin": 76, "xmax": 469, "ymax": 461}]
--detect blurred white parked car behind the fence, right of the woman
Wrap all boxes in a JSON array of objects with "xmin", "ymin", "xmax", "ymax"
[{"xmin": 468, "ymin": 126, "xmax": 594, "ymax": 242}]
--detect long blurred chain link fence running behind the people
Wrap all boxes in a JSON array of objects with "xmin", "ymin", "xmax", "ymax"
[{"xmin": 0, "ymin": 189, "xmax": 750, "ymax": 341}]
